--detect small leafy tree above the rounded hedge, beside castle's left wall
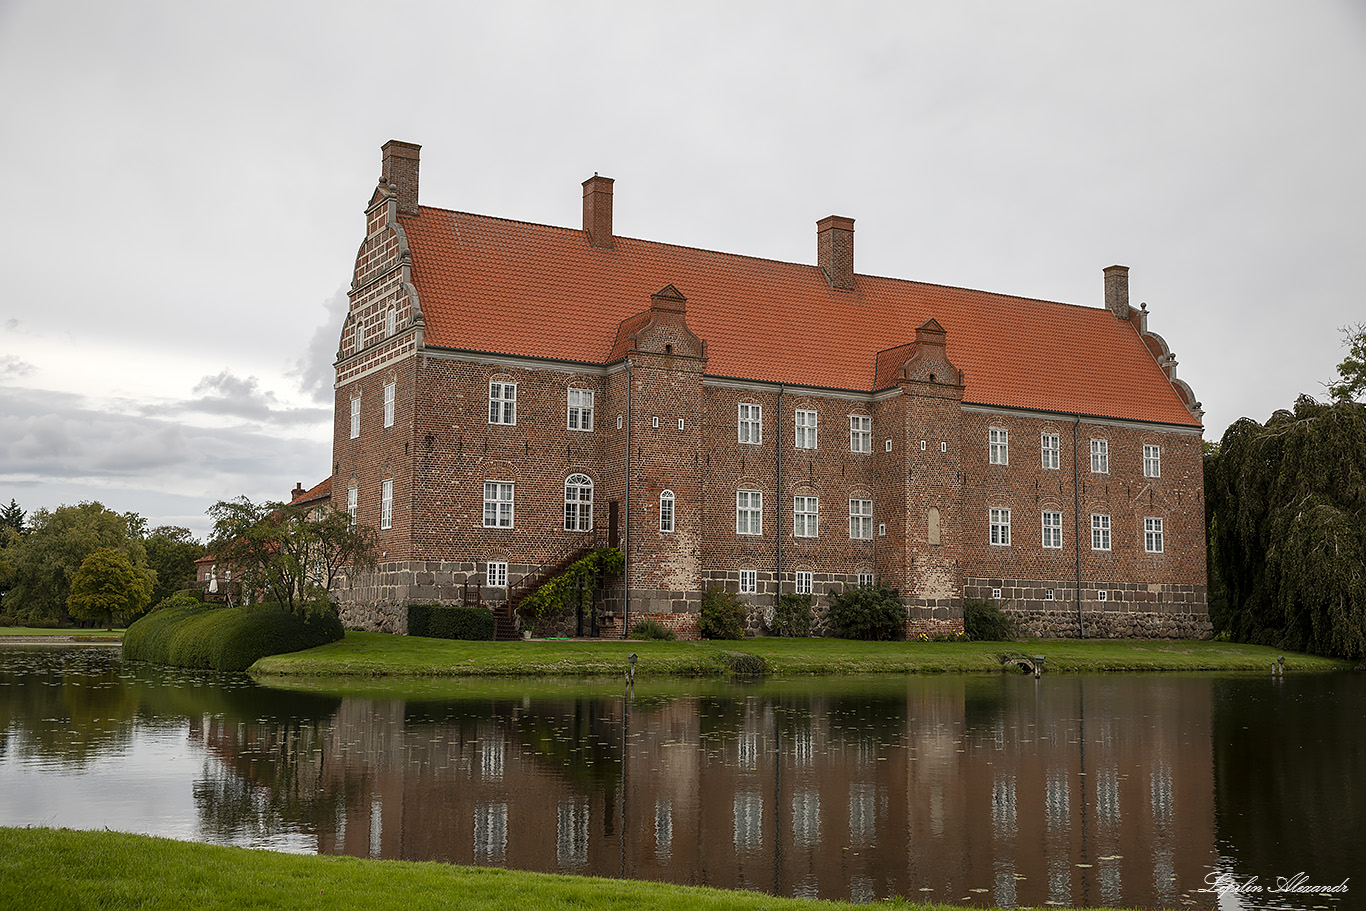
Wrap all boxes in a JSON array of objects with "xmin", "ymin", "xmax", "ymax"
[{"xmin": 209, "ymin": 497, "xmax": 376, "ymax": 613}]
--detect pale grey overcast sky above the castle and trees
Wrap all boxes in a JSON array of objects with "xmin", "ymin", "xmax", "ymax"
[{"xmin": 0, "ymin": 0, "xmax": 1366, "ymax": 534}]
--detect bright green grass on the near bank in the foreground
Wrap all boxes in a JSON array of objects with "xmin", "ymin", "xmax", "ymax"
[{"xmin": 0, "ymin": 828, "xmax": 1120, "ymax": 911}]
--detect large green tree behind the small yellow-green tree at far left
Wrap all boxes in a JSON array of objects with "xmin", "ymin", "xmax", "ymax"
[{"xmin": 4, "ymin": 501, "xmax": 148, "ymax": 621}]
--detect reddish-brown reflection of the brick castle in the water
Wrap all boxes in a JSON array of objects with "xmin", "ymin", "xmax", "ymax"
[{"xmin": 201, "ymin": 677, "xmax": 1214, "ymax": 906}]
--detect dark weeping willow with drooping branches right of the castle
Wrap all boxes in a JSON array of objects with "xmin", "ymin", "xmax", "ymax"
[{"xmin": 1205, "ymin": 396, "xmax": 1366, "ymax": 658}]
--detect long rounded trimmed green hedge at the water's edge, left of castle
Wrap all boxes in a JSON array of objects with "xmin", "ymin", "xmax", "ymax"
[{"xmin": 123, "ymin": 595, "xmax": 346, "ymax": 671}]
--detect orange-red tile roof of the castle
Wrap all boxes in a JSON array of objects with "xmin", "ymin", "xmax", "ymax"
[{"xmin": 400, "ymin": 206, "xmax": 1199, "ymax": 426}]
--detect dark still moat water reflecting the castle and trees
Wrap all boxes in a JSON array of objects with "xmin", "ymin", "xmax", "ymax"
[{"xmin": 0, "ymin": 646, "xmax": 1366, "ymax": 908}]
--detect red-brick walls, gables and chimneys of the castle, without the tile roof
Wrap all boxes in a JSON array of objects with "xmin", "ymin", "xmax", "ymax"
[{"xmin": 332, "ymin": 143, "xmax": 1209, "ymax": 636}]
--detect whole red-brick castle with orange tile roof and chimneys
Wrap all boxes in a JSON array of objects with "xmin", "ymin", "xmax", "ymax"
[{"xmin": 331, "ymin": 141, "xmax": 1209, "ymax": 636}]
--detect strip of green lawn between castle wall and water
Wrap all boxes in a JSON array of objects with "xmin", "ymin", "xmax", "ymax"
[{"xmin": 250, "ymin": 632, "xmax": 1352, "ymax": 677}]
